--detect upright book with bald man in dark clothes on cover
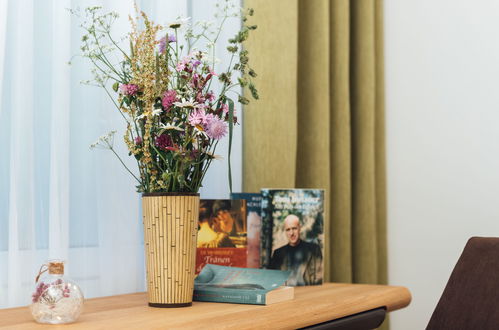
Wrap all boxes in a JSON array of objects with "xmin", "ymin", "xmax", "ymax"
[{"xmin": 260, "ymin": 189, "xmax": 324, "ymax": 286}]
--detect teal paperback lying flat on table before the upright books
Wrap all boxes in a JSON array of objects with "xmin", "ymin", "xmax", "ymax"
[{"xmin": 193, "ymin": 264, "xmax": 294, "ymax": 305}]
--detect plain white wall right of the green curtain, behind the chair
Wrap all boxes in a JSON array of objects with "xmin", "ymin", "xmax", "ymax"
[{"xmin": 385, "ymin": 0, "xmax": 499, "ymax": 330}]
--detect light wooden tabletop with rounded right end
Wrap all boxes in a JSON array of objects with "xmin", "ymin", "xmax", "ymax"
[{"xmin": 0, "ymin": 283, "xmax": 411, "ymax": 330}]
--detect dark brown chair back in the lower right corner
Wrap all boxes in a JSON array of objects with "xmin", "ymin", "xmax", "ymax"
[{"xmin": 426, "ymin": 237, "xmax": 499, "ymax": 330}]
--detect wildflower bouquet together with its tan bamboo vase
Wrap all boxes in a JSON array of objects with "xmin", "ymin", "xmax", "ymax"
[{"xmin": 75, "ymin": 1, "xmax": 258, "ymax": 307}]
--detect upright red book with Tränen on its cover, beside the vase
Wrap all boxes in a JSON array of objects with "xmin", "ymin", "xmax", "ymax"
[{"xmin": 196, "ymin": 199, "xmax": 247, "ymax": 274}]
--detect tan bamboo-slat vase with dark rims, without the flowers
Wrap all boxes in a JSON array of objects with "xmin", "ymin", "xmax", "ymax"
[{"xmin": 142, "ymin": 193, "xmax": 199, "ymax": 307}]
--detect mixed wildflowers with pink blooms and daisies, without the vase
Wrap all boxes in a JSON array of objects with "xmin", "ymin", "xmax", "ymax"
[{"xmin": 81, "ymin": 0, "xmax": 258, "ymax": 193}]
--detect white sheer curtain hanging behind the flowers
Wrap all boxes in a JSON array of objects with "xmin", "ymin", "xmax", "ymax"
[{"xmin": 0, "ymin": 0, "xmax": 242, "ymax": 308}]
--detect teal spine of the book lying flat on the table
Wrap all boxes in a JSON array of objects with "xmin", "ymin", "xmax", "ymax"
[{"xmin": 193, "ymin": 289, "xmax": 265, "ymax": 305}]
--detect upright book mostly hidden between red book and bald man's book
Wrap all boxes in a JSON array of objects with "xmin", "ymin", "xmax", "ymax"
[{"xmin": 231, "ymin": 193, "xmax": 262, "ymax": 268}]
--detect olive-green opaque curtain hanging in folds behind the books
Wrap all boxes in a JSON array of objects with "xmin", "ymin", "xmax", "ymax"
[{"xmin": 243, "ymin": 0, "xmax": 387, "ymax": 283}]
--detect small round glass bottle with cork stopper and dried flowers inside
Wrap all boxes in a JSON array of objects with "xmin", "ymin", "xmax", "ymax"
[{"xmin": 30, "ymin": 260, "xmax": 83, "ymax": 324}]
